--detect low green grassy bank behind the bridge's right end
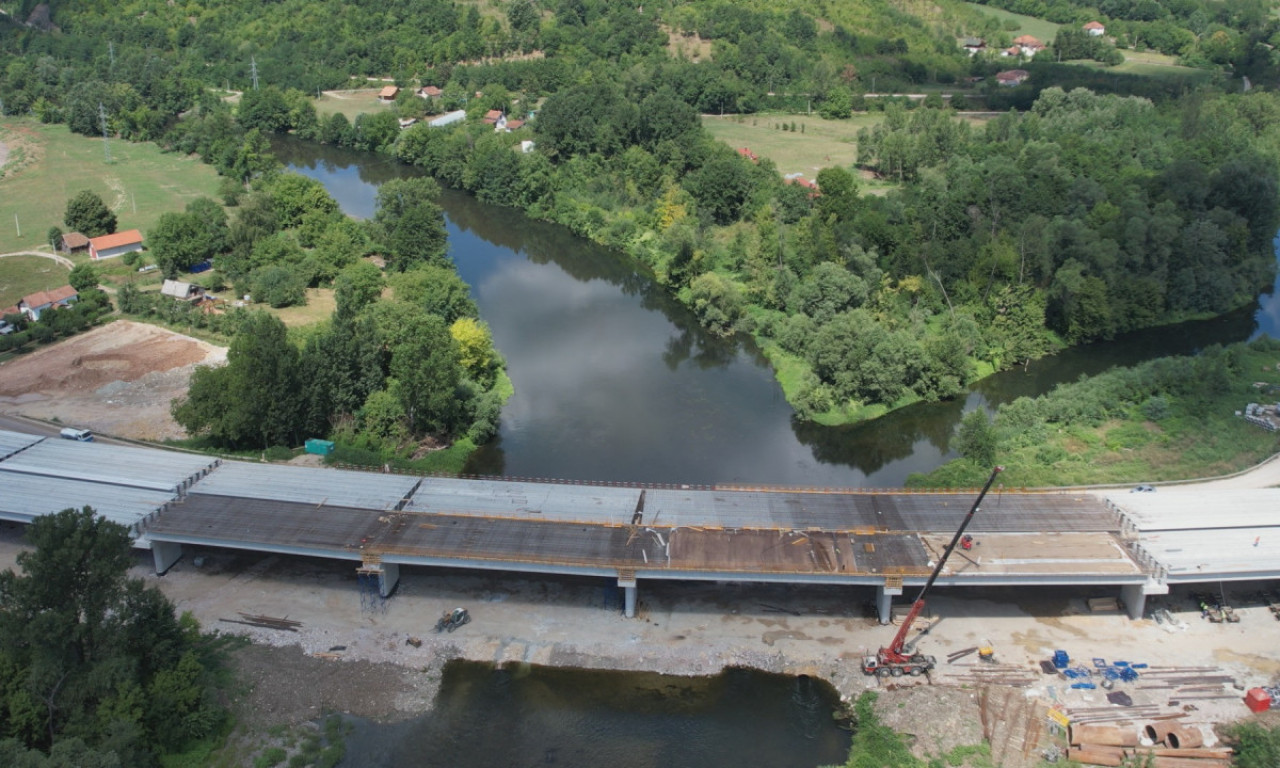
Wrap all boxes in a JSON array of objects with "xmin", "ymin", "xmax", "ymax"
[{"xmin": 906, "ymin": 337, "xmax": 1280, "ymax": 488}]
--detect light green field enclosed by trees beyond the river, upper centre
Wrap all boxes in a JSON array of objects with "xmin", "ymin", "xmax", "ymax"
[{"xmin": 703, "ymin": 114, "xmax": 892, "ymax": 191}]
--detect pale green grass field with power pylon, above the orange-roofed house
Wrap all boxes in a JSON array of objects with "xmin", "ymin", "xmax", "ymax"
[{"xmin": 0, "ymin": 118, "xmax": 218, "ymax": 253}]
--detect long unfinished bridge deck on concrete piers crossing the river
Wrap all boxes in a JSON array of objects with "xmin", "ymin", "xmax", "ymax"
[{"xmin": 0, "ymin": 431, "xmax": 1280, "ymax": 622}]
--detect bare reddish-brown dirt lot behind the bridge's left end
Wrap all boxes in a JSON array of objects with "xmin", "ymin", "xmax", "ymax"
[{"xmin": 0, "ymin": 320, "xmax": 227, "ymax": 440}]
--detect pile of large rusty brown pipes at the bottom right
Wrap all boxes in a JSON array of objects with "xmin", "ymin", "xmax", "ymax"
[{"xmin": 1066, "ymin": 721, "xmax": 1231, "ymax": 768}]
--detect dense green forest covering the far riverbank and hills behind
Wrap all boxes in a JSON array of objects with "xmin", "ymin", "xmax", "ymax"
[{"xmin": 0, "ymin": 0, "xmax": 1280, "ymax": 439}]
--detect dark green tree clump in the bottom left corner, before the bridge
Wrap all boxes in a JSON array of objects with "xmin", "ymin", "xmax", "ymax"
[{"xmin": 0, "ymin": 507, "xmax": 224, "ymax": 765}]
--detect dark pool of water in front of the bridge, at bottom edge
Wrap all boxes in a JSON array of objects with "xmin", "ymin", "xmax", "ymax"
[{"xmin": 343, "ymin": 662, "xmax": 849, "ymax": 768}]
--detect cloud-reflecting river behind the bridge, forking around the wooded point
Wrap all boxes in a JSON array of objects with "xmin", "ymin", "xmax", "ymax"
[{"xmin": 267, "ymin": 138, "xmax": 1280, "ymax": 488}]
